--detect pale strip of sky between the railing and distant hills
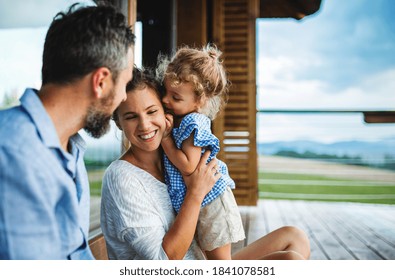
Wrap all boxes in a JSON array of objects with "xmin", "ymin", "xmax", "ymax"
[{"xmin": 257, "ymin": 113, "xmax": 394, "ymax": 143}]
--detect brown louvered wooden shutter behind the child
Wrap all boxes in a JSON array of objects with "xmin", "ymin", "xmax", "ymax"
[{"xmin": 213, "ymin": 0, "xmax": 260, "ymax": 205}]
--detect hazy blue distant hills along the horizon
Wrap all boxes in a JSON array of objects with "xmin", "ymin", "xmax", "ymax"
[{"xmin": 257, "ymin": 137, "xmax": 395, "ymax": 163}]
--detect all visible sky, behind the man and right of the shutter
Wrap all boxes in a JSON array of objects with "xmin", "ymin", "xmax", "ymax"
[{"xmin": 0, "ymin": 0, "xmax": 395, "ymax": 145}]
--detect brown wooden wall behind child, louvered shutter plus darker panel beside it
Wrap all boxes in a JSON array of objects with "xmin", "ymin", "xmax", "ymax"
[{"xmin": 177, "ymin": 0, "xmax": 260, "ymax": 205}]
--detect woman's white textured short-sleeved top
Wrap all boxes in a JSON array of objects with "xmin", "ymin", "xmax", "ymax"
[{"xmin": 100, "ymin": 160, "xmax": 204, "ymax": 260}]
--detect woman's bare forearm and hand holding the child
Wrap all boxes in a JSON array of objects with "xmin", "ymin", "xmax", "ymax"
[{"xmin": 162, "ymin": 151, "xmax": 221, "ymax": 260}]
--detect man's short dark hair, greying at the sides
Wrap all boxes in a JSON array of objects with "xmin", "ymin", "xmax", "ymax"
[{"xmin": 42, "ymin": 4, "xmax": 135, "ymax": 85}]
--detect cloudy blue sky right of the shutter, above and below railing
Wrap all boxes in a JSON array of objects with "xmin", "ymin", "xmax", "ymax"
[{"xmin": 257, "ymin": 0, "xmax": 395, "ymax": 144}]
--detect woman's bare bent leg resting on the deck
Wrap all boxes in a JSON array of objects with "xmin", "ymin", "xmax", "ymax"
[{"xmin": 232, "ymin": 226, "xmax": 310, "ymax": 260}]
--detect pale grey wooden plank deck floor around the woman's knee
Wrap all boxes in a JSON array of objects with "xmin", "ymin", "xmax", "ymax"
[{"xmin": 234, "ymin": 199, "xmax": 395, "ymax": 260}]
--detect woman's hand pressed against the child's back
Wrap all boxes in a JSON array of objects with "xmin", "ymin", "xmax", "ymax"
[{"xmin": 183, "ymin": 150, "xmax": 221, "ymax": 201}]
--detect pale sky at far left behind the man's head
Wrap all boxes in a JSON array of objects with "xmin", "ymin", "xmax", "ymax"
[{"xmin": 0, "ymin": 0, "xmax": 93, "ymax": 98}]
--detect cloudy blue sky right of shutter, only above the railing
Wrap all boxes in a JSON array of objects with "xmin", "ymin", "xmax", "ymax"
[{"xmin": 257, "ymin": 0, "xmax": 395, "ymax": 109}]
